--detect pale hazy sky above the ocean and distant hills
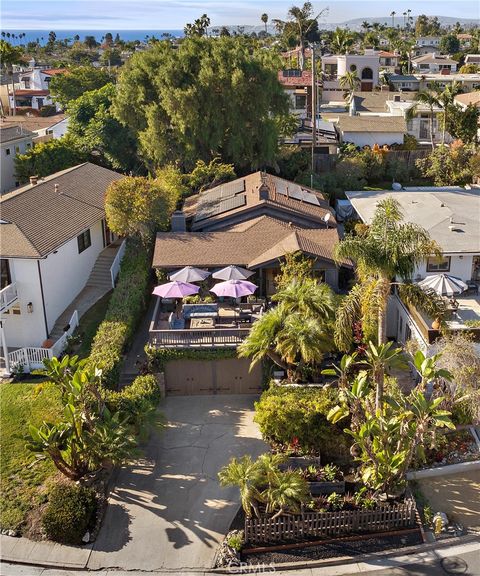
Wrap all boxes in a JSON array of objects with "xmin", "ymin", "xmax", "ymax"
[{"xmin": 0, "ymin": 0, "xmax": 480, "ymax": 32}]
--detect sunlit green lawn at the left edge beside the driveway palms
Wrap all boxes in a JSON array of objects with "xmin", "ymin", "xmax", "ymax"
[{"xmin": 0, "ymin": 380, "xmax": 61, "ymax": 529}]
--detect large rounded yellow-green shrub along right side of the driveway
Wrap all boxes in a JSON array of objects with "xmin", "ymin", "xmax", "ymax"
[{"xmin": 255, "ymin": 386, "xmax": 350, "ymax": 462}]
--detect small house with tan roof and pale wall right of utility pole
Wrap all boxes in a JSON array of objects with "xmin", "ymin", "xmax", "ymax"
[{"xmin": 337, "ymin": 115, "xmax": 407, "ymax": 147}]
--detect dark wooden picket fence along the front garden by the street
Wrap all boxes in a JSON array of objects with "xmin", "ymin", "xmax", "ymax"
[{"xmin": 245, "ymin": 500, "xmax": 416, "ymax": 544}]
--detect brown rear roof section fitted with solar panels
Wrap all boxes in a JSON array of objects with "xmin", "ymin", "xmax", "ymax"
[{"xmin": 184, "ymin": 172, "xmax": 335, "ymax": 230}]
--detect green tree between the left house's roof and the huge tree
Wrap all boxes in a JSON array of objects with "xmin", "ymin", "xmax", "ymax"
[{"xmin": 67, "ymin": 84, "xmax": 137, "ymax": 172}]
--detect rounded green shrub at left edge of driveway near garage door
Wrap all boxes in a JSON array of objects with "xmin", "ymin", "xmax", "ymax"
[{"xmin": 105, "ymin": 374, "xmax": 161, "ymax": 428}]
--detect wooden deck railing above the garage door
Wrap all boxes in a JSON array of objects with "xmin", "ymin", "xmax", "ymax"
[{"xmin": 150, "ymin": 328, "xmax": 250, "ymax": 348}]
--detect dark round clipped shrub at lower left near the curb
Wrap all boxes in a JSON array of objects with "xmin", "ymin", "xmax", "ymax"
[{"xmin": 42, "ymin": 484, "xmax": 97, "ymax": 544}]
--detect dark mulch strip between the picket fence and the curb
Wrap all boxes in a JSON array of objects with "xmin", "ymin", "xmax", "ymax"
[{"xmin": 242, "ymin": 531, "xmax": 423, "ymax": 564}]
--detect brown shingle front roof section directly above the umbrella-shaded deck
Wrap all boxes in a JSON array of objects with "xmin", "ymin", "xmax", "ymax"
[{"xmin": 153, "ymin": 216, "xmax": 339, "ymax": 268}]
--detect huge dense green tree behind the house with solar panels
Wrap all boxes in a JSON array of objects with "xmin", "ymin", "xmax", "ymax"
[{"xmin": 114, "ymin": 37, "xmax": 288, "ymax": 172}]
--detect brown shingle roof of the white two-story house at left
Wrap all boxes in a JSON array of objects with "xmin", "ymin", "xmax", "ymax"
[{"xmin": 0, "ymin": 163, "xmax": 123, "ymax": 258}]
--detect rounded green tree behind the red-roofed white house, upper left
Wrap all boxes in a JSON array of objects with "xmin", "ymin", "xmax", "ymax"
[{"xmin": 50, "ymin": 66, "xmax": 112, "ymax": 108}]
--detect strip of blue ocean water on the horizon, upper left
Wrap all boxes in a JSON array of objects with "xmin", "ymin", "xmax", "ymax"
[{"xmin": 1, "ymin": 28, "xmax": 184, "ymax": 45}]
